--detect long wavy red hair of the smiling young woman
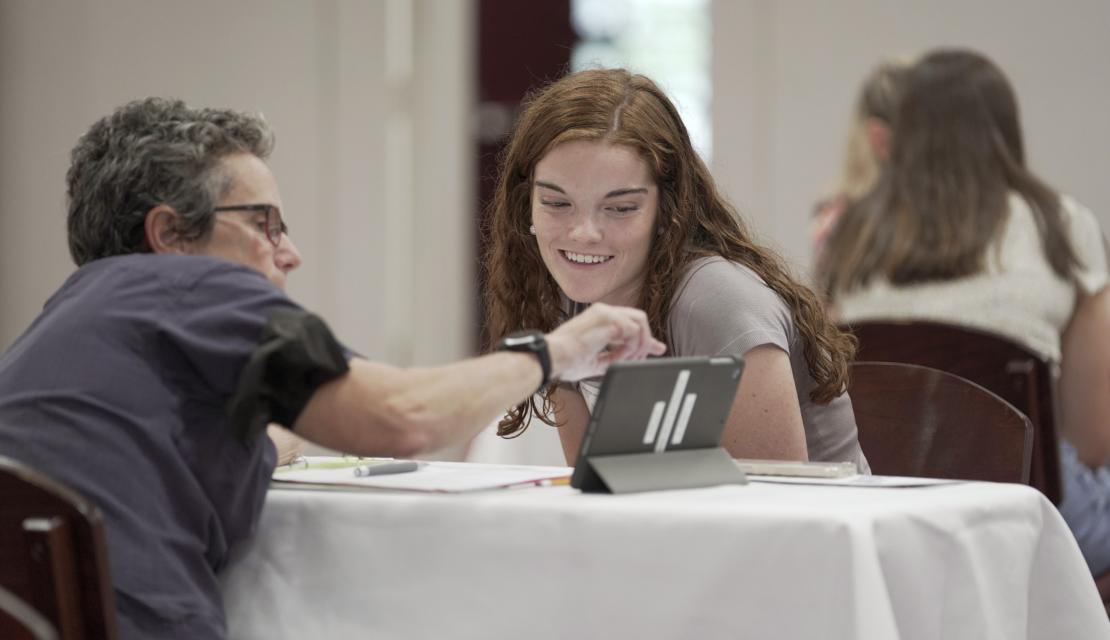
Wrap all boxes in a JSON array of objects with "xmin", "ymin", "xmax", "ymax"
[{"xmin": 485, "ymin": 69, "xmax": 856, "ymax": 436}]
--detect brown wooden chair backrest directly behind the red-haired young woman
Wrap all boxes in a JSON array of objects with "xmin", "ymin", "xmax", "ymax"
[{"xmin": 848, "ymin": 362, "xmax": 1032, "ymax": 484}]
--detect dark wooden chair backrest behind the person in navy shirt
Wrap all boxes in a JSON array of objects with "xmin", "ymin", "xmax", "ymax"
[{"xmin": 0, "ymin": 456, "xmax": 117, "ymax": 640}]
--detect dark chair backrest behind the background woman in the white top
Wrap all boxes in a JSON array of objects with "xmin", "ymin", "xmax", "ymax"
[{"xmin": 846, "ymin": 322, "xmax": 1063, "ymax": 504}]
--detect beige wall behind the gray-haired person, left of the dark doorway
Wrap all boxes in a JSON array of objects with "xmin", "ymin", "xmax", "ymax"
[{"xmin": 0, "ymin": 0, "xmax": 474, "ymax": 364}]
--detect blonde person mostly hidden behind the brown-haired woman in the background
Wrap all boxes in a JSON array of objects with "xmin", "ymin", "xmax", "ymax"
[{"xmin": 809, "ymin": 58, "xmax": 912, "ymax": 255}]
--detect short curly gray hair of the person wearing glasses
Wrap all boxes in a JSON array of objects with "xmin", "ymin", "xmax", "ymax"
[{"xmin": 65, "ymin": 98, "xmax": 274, "ymax": 266}]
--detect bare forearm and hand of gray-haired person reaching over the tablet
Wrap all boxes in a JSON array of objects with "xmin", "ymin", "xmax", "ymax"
[{"xmin": 294, "ymin": 304, "xmax": 665, "ymax": 456}]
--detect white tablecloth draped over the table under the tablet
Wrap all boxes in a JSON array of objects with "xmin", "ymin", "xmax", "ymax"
[{"xmin": 223, "ymin": 472, "xmax": 1110, "ymax": 640}]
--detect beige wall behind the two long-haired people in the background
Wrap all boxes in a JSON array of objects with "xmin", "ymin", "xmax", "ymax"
[{"xmin": 713, "ymin": 0, "xmax": 1110, "ymax": 276}]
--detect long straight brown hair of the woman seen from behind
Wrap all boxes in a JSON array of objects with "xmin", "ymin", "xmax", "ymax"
[{"xmin": 817, "ymin": 50, "xmax": 1079, "ymax": 298}]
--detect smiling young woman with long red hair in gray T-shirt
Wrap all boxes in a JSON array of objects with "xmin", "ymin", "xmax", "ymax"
[{"xmin": 485, "ymin": 69, "xmax": 869, "ymax": 473}]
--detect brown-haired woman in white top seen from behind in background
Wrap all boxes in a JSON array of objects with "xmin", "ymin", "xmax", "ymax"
[{"xmin": 817, "ymin": 49, "xmax": 1110, "ymax": 569}]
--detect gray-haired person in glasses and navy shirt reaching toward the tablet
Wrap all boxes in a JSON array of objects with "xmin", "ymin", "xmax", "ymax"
[{"xmin": 0, "ymin": 98, "xmax": 664, "ymax": 639}]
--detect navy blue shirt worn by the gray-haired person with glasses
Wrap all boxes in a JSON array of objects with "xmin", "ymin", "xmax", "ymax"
[{"xmin": 0, "ymin": 254, "xmax": 297, "ymax": 639}]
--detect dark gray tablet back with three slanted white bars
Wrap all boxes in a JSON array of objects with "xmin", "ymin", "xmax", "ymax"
[{"xmin": 571, "ymin": 356, "xmax": 744, "ymax": 489}]
